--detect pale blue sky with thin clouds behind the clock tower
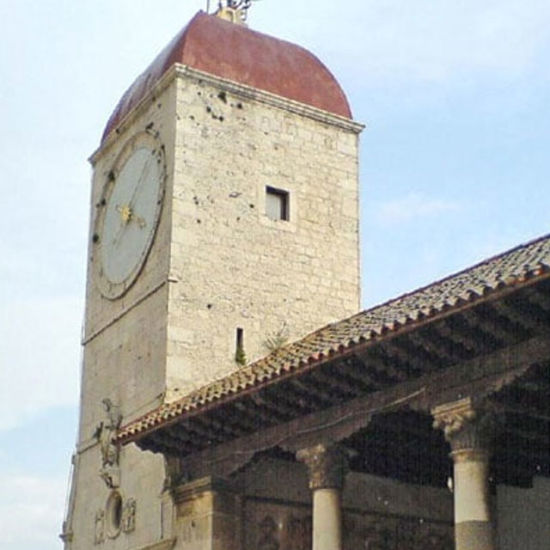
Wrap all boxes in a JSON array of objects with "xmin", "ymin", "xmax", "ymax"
[{"xmin": 0, "ymin": 0, "xmax": 550, "ymax": 550}]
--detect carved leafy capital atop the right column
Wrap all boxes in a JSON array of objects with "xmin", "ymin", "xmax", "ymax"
[{"xmin": 432, "ymin": 397, "xmax": 497, "ymax": 454}]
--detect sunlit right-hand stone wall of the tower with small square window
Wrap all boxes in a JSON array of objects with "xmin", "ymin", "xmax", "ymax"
[{"xmin": 168, "ymin": 74, "xmax": 359, "ymax": 398}]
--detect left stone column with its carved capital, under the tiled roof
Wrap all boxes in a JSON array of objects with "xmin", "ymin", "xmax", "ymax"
[{"xmin": 296, "ymin": 444, "xmax": 347, "ymax": 550}]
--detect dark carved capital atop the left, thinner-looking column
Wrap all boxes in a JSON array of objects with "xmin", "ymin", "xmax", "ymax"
[{"xmin": 296, "ymin": 444, "xmax": 348, "ymax": 490}]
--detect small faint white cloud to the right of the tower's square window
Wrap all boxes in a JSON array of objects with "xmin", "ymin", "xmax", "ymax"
[{"xmin": 373, "ymin": 193, "xmax": 460, "ymax": 225}]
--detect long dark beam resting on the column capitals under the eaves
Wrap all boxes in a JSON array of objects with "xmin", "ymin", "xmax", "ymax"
[{"xmin": 175, "ymin": 337, "xmax": 550, "ymax": 477}]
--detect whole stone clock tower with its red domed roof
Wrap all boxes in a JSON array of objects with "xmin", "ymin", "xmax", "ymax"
[{"xmin": 62, "ymin": 8, "xmax": 361, "ymax": 550}]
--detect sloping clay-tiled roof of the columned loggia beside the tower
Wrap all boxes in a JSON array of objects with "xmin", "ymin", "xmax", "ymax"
[{"xmin": 117, "ymin": 235, "xmax": 550, "ymax": 442}]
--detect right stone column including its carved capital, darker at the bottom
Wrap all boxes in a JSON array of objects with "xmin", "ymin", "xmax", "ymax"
[{"xmin": 432, "ymin": 398, "xmax": 496, "ymax": 550}]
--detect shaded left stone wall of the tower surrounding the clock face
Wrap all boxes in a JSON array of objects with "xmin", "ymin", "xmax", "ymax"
[{"xmin": 68, "ymin": 78, "xmax": 179, "ymax": 550}]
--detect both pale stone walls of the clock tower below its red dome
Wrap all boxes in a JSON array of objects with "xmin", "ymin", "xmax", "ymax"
[{"xmin": 68, "ymin": 68, "xmax": 359, "ymax": 550}]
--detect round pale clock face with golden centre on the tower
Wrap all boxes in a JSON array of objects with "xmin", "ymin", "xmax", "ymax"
[{"xmin": 97, "ymin": 139, "xmax": 165, "ymax": 299}]
